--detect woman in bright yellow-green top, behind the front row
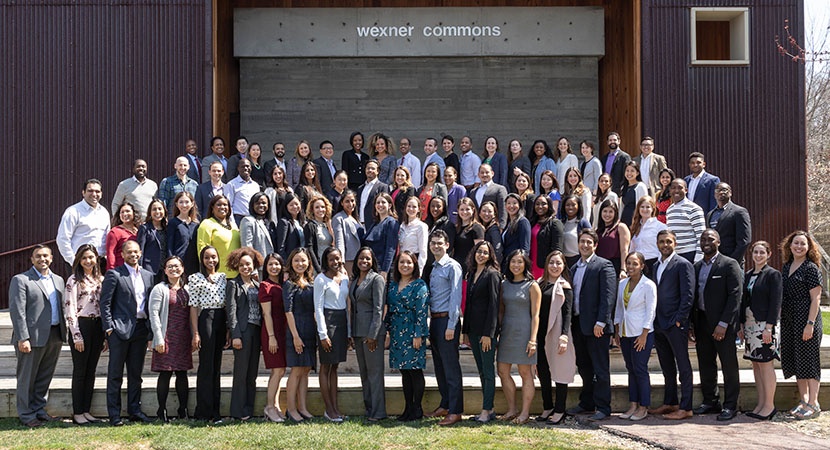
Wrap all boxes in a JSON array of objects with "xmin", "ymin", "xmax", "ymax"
[{"xmin": 196, "ymin": 195, "xmax": 240, "ymax": 278}]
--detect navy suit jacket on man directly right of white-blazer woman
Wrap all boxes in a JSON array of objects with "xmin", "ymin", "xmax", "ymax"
[{"xmin": 651, "ymin": 254, "xmax": 695, "ymax": 330}]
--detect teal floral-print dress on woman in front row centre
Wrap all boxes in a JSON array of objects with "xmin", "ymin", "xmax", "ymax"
[{"xmin": 386, "ymin": 279, "xmax": 429, "ymax": 370}]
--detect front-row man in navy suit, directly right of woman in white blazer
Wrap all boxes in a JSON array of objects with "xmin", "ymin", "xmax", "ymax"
[{"xmin": 648, "ymin": 230, "xmax": 695, "ymax": 420}]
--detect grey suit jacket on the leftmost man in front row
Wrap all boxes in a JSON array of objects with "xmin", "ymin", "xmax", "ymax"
[{"xmin": 9, "ymin": 267, "xmax": 66, "ymax": 348}]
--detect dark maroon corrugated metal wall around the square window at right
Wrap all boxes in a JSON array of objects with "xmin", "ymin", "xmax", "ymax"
[{"xmin": 644, "ymin": 0, "xmax": 807, "ymax": 259}]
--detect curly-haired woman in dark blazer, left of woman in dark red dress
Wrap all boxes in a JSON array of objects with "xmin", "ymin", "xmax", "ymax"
[{"xmin": 225, "ymin": 247, "xmax": 265, "ymax": 421}]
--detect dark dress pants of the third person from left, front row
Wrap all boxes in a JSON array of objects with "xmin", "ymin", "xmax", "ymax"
[{"xmin": 107, "ymin": 319, "xmax": 150, "ymax": 420}]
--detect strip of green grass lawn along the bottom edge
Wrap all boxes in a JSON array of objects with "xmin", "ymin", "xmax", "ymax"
[{"xmin": 0, "ymin": 418, "xmax": 632, "ymax": 450}]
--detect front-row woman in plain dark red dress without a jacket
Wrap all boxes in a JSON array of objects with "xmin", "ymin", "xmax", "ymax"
[{"xmin": 259, "ymin": 253, "xmax": 287, "ymax": 422}]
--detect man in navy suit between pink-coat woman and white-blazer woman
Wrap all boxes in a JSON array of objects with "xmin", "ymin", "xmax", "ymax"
[{"xmin": 568, "ymin": 228, "xmax": 617, "ymax": 420}]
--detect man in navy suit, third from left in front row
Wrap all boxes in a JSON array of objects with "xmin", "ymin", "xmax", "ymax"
[{"xmin": 101, "ymin": 241, "xmax": 153, "ymax": 426}]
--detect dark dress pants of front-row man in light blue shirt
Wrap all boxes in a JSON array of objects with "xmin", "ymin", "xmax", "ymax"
[{"xmin": 429, "ymin": 317, "xmax": 464, "ymax": 414}]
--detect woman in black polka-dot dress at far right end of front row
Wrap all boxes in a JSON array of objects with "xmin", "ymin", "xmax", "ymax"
[{"xmin": 781, "ymin": 230, "xmax": 822, "ymax": 419}]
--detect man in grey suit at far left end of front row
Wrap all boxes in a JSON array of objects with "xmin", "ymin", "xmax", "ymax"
[{"xmin": 9, "ymin": 245, "xmax": 66, "ymax": 428}]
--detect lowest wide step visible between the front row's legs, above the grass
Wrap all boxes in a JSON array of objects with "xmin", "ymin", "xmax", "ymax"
[{"xmin": 0, "ymin": 369, "xmax": 830, "ymax": 417}]
